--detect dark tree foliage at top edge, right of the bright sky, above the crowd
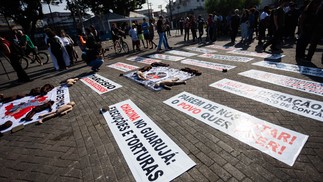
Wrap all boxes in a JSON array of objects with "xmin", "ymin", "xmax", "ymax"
[{"xmin": 205, "ymin": 0, "xmax": 260, "ymax": 15}]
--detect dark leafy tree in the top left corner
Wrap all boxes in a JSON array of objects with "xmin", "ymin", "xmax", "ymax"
[{"xmin": 0, "ymin": 0, "xmax": 43, "ymax": 37}]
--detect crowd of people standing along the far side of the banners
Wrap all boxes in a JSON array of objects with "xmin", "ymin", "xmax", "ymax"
[{"xmin": 1, "ymin": 0, "xmax": 323, "ymax": 82}]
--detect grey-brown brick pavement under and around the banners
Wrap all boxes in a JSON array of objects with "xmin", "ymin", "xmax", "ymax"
[{"xmin": 0, "ymin": 31, "xmax": 323, "ymax": 181}]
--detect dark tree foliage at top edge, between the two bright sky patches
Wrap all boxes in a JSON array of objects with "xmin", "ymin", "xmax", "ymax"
[{"xmin": 83, "ymin": 0, "xmax": 146, "ymax": 16}]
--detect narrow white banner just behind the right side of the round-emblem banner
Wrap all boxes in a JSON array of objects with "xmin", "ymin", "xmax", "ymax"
[{"xmin": 181, "ymin": 59, "xmax": 236, "ymax": 71}]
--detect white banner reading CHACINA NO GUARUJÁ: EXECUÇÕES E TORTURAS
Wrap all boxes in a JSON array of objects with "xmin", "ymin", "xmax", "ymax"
[{"xmin": 103, "ymin": 100, "xmax": 196, "ymax": 182}]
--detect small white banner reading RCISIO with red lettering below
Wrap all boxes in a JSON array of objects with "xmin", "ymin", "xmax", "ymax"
[{"xmin": 80, "ymin": 74, "xmax": 122, "ymax": 94}]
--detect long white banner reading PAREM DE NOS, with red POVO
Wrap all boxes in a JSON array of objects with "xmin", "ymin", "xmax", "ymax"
[{"xmin": 164, "ymin": 92, "xmax": 308, "ymax": 166}]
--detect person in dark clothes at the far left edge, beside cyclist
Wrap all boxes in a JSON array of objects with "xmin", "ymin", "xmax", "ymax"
[{"xmin": 0, "ymin": 37, "xmax": 31, "ymax": 83}]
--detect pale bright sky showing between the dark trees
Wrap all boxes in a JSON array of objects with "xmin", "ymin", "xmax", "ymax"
[{"xmin": 43, "ymin": 0, "xmax": 169, "ymax": 13}]
